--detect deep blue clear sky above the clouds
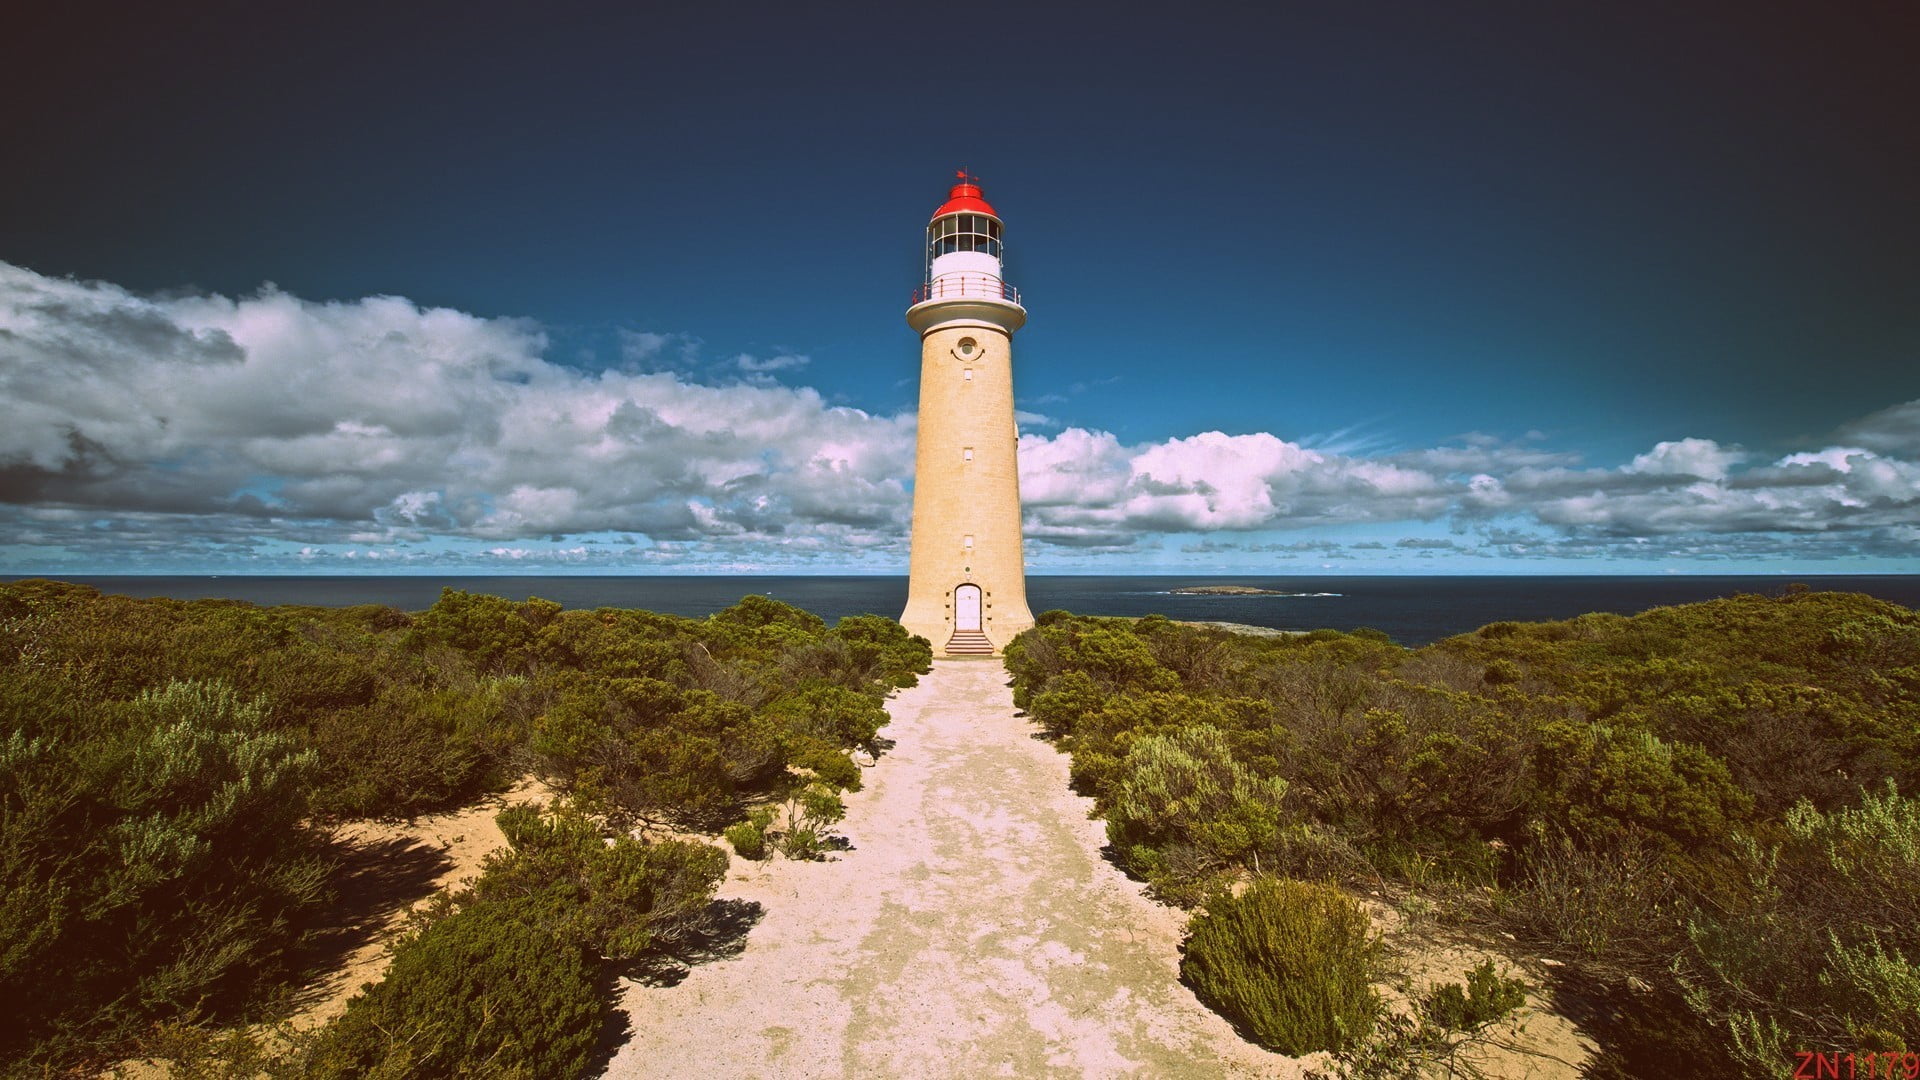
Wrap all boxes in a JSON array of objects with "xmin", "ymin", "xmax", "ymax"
[{"xmin": 0, "ymin": 4, "xmax": 1920, "ymax": 571}]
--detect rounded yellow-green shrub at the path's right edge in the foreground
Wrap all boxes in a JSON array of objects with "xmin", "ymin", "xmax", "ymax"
[{"xmin": 1181, "ymin": 876, "xmax": 1380, "ymax": 1057}]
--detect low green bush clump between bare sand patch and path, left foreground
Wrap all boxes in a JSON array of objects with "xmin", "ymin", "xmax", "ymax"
[{"xmin": 299, "ymin": 805, "xmax": 726, "ymax": 1080}]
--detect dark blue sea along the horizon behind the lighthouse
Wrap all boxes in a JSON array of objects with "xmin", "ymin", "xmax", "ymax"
[{"xmin": 15, "ymin": 575, "xmax": 1920, "ymax": 646}]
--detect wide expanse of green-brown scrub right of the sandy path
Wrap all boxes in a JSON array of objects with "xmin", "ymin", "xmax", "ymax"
[{"xmin": 1008, "ymin": 588, "xmax": 1920, "ymax": 1074}]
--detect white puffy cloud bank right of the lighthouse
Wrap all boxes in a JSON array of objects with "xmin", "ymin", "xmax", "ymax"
[{"xmin": 1020, "ymin": 417, "xmax": 1920, "ymax": 557}]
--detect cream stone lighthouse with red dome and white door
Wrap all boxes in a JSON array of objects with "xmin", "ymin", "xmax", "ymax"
[{"xmin": 900, "ymin": 173, "xmax": 1033, "ymax": 655}]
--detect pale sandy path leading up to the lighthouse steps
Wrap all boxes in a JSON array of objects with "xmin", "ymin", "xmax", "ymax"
[{"xmin": 609, "ymin": 661, "xmax": 1300, "ymax": 1080}]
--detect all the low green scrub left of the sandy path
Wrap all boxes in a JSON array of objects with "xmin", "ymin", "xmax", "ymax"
[{"xmin": 0, "ymin": 580, "xmax": 931, "ymax": 1076}]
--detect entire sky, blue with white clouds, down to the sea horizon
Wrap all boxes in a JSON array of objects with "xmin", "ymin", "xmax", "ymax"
[{"xmin": 0, "ymin": 2, "xmax": 1920, "ymax": 575}]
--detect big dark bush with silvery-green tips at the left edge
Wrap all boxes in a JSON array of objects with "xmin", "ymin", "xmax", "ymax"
[{"xmin": 0, "ymin": 680, "xmax": 328, "ymax": 1059}]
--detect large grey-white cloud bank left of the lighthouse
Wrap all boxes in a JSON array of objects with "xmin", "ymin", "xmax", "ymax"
[{"xmin": 0, "ymin": 263, "xmax": 914, "ymax": 564}]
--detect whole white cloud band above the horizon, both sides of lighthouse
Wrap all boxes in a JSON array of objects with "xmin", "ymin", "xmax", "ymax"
[{"xmin": 0, "ymin": 263, "xmax": 1920, "ymax": 573}]
